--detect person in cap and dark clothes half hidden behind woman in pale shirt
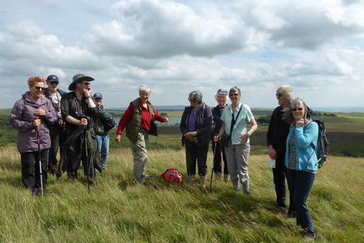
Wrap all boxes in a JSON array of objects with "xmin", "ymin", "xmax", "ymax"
[{"xmin": 212, "ymin": 89, "xmax": 229, "ymax": 182}]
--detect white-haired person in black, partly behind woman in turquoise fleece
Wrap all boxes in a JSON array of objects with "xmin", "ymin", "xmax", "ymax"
[{"xmin": 267, "ymin": 85, "xmax": 295, "ymax": 213}]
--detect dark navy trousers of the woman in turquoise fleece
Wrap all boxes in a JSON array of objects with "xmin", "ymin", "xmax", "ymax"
[{"xmin": 287, "ymin": 169, "xmax": 315, "ymax": 233}]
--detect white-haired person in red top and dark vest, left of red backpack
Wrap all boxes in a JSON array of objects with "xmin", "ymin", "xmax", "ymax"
[{"xmin": 116, "ymin": 85, "xmax": 168, "ymax": 184}]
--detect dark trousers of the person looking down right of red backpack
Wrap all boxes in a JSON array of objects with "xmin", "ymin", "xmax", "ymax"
[{"xmin": 185, "ymin": 141, "xmax": 209, "ymax": 176}]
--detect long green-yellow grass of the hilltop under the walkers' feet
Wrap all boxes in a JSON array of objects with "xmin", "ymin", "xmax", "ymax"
[{"xmin": 0, "ymin": 146, "xmax": 364, "ymax": 243}]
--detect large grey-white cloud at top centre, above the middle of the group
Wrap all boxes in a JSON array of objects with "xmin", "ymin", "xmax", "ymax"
[{"xmin": 89, "ymin": 0, "xmax": 251, "ymax": 58}]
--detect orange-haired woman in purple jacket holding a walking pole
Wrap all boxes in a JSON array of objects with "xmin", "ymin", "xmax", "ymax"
[{"xmin": 10, "ymin": 77, "xmax": 57, "ymax": 196}]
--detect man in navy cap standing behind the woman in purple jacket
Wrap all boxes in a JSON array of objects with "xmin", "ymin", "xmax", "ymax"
[{"xmin": 44, "ymin": 74, "xmax": 65, "ymax": 177}]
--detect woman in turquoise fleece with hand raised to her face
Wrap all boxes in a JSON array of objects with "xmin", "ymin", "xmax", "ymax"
[{"xmin": 285, "ymin": 98, "xmax": 319, "ymax": 239}]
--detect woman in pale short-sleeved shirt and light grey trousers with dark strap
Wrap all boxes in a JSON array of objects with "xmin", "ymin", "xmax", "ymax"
[{"xmin": 214, "ymin": 87, "xmax": 258, "ymax": 193}]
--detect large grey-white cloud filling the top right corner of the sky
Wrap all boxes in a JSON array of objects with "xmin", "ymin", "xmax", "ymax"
[{"xmin": 232, "ymin": 0, "xmax": 364, "ymax": 50}]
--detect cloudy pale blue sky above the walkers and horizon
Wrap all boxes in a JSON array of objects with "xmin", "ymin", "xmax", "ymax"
[{"xmin": 0, "ymin": 0, "xmax": 364, "ymax": 108}]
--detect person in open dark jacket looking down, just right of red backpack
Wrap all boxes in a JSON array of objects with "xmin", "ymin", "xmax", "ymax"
[{"xmin": 180, "ymin": 91, "xmax": 212, "ymax": 188}]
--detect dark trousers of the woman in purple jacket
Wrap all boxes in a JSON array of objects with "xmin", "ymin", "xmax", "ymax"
[{"xmin": 20, "ymin": 149, "xmax": 49, "ymax": 189}]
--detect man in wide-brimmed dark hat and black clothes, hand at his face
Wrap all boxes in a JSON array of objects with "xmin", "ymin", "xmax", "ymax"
[{"xmin": 61, "ymin": 74, "xmax": 97, "ymax": 180}]
